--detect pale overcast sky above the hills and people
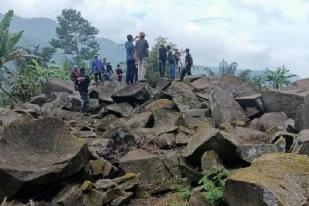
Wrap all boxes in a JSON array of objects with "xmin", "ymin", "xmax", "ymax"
[{"xmin": 0, "ymin": 0, "xmax": 309, "ymax": 77}]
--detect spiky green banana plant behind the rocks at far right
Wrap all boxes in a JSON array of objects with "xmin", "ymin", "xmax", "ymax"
[{"xmin": 264, "ymin": 66, "xmax": 296, "ymax": 89}]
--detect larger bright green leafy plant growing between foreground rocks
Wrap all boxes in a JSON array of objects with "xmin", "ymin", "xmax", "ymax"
[{"xmin": 199, "ymin": 168, "xmax": 229, "ymax": 205}]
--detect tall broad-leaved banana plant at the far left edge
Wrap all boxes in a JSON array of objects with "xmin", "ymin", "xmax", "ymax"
[{"xmin": 0, "ymin": 10, "xmax": 26, "ymax": 100}]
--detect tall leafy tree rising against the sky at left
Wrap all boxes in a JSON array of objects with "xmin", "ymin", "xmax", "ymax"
[{"xmin": 50, "ymin": 9, "xmax": 99, "ymax": 63}]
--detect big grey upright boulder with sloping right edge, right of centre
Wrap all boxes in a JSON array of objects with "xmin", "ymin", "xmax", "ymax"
[{"xmin": 209, "ymin": 87, "xmax": 247, "ymax": 125}]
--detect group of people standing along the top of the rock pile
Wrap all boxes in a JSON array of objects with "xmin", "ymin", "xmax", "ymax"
[{"xmin": 71, "ymin": 32, "xmax": 193, "ymax": 112}]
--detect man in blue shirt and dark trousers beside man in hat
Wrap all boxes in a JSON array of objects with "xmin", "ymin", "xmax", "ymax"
[{"xmin": 125, "ymin": 34, "xmax": 135, "ymax": 85}]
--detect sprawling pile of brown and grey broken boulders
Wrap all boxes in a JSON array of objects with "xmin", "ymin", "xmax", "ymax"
[{"xmin": 0, "ymin": 76, "xmax": 309, "ymax": 206}]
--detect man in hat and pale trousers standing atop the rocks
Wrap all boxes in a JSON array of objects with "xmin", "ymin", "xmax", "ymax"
[{"xmin": 135, "ymin": 32, "xmax": 149, "ymax": 82}]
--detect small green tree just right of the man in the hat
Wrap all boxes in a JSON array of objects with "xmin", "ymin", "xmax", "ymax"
[{"xmin": 146, "ymin": 36, "xmax": 176, "ymax": 81}]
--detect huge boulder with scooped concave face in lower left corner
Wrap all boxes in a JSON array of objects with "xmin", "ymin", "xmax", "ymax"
[{"xmin": 0, "ymin": 118, "xmax": 88, "ymax": 199}]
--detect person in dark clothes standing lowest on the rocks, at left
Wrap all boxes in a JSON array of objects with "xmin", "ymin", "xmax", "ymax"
[{"xmin": 77, "ymin": 68, "xmax": 90, "ymax": 112}]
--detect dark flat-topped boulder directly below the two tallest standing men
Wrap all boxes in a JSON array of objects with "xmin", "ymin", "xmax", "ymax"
[{"xmin": 112, "ymin": 84, "xmax": 150, "ymax": 104}]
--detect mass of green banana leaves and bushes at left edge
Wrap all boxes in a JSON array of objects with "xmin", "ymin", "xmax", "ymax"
[{"xmin": 0, "ymin": 10, "xmax": 69, "ymax": 106}]
